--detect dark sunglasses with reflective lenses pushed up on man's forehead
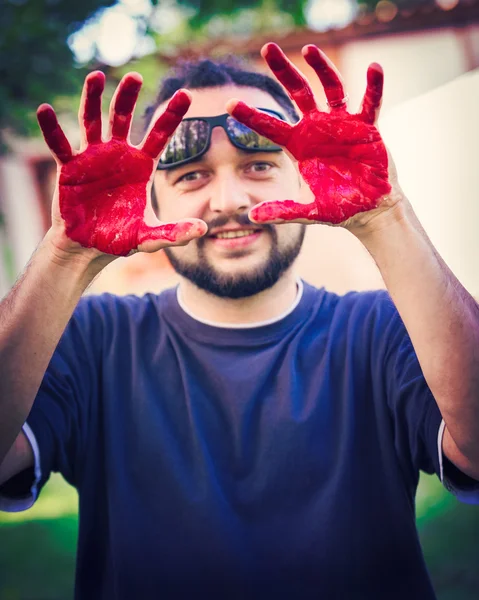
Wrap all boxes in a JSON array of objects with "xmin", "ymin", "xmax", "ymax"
[{"xmin": 158, "ymin": 108, "xmax": 286, "ymax": 170}]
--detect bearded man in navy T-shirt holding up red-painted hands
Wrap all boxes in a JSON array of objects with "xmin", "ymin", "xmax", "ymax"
[{"xmin": 0, "ymin": 44, "xmax": 479, "ymax": 600}]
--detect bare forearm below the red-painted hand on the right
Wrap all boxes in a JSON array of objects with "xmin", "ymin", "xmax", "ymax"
[{"xmin": 356, "ymin": 200, "xmax": 479, "ymax": 475}]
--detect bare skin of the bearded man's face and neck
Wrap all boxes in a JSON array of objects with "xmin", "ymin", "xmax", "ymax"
[{"xmin": 155, "ymin": 86, "xmax": 305, "ymax": 323}]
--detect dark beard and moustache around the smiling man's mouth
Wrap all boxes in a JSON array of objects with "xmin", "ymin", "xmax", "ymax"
[{"xmin": 164, "ymin": 214, "xmax": 306, "ymax": 299}]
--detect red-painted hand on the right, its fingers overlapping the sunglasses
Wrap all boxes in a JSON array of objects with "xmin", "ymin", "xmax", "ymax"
[{"xmin": 228, "ymin": 43, "xmax": 391, "ymax": 224}]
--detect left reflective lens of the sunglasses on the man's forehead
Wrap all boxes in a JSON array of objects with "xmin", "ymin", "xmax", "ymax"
[{"xmin": 160, "ymin": 119, "xmax": 209, "ymax": 165}]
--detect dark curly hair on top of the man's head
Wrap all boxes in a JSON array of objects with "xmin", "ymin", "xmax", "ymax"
[{"xmin": 144, "ymin": 58, "xmax": 299, "ymax": 128}]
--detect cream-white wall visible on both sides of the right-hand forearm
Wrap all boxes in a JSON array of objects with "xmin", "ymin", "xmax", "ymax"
[{"xmin": 299, "ymin": 69, "xmax": 479, "ymax": 297}]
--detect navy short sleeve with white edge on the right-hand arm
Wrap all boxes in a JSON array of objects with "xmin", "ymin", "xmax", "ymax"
[{"xmin": 384, "ymin": 297, "xmax": 479, "ymax": 502}]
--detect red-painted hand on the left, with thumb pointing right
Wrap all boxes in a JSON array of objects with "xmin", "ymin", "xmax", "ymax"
[{"xmin": 37, "ymin": 71, "xmax": 207, "ymax": 256}]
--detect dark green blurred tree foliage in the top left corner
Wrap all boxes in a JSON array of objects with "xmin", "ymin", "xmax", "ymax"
[{"xmin": 0, "ymin": 0, "xmax": 146, "ymax": 149}]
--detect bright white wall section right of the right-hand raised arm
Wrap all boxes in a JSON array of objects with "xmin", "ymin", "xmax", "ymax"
[{"xmin": 380, "ymin": 69, "xmax": 479, "ymax": 296}]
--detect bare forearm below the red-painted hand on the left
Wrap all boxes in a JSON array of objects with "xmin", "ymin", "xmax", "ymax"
[{"xmin": 0, "ymin": 227, "xmax": 106, "ymax": 464}]
